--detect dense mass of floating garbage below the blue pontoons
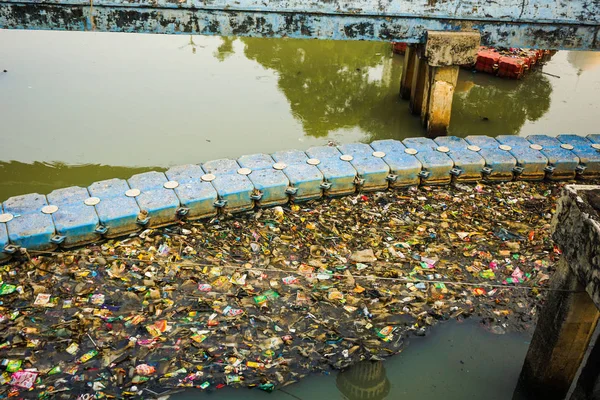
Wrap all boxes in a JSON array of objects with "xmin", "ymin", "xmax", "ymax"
[{"xmin": 0, "ymin": 182, "xmax": 561, "ymax": 399}]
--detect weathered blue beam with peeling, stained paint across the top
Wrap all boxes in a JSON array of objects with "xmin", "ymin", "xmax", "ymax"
[{"xmin": 0, "ymin": 0, "xmax": 600, "ymax": 50}]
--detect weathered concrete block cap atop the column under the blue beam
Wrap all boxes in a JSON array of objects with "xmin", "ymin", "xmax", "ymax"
[{"xmin": 425, "ymin": 31, "xmax": 481, "ymax": 67}]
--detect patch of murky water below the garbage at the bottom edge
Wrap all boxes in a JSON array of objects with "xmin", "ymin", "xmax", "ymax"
[{"xmin": 175, "ymin": 320, "xmax": 530, "ymax": 400}]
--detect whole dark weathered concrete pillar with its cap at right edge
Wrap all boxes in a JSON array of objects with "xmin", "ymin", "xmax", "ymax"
[{"xmin": 515, "ymin": 185, "xmax": 600, "ymax": 400}]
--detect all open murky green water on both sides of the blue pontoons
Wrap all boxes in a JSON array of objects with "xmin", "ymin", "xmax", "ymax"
[{"xmin": 0, "ymin": 30, "xmax": 600, "ymax": 400}]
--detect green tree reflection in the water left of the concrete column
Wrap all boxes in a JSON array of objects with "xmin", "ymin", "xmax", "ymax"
[{"xmin": 241, "ymin": 38, "xmax": 422, "ymax": 140}]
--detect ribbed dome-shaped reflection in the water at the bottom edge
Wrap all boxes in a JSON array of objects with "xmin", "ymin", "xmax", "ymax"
[{"xmin": 336, "ymin": 361, "xmax": 390, "ymax": 400}]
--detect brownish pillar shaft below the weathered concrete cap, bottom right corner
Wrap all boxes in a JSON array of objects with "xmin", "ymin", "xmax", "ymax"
[{"xmin": 517, "ymin": 258, "xmax": 600, "ymax": 400}]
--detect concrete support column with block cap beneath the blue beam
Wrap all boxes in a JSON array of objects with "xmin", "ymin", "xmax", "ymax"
[{"xmin": 400, "ymin": 31, "xmax": 480, "ymax": 136}]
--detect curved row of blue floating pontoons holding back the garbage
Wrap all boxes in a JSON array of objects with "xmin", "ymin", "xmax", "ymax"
[{"xmin": 0, "ymin": 134, "xmax": 600, "ymax": 261}]
